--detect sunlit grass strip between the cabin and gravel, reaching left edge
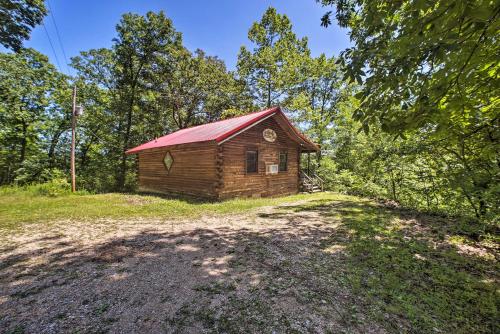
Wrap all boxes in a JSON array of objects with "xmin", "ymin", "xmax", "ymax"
[{"xmin": 0, "ymin": 187, "xmax": 337, "ymax": 230}]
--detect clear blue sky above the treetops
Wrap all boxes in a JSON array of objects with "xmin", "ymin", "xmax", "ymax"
[{"xmin": 19, "ymin": 0, "xmax": 349, "ymax": 71}]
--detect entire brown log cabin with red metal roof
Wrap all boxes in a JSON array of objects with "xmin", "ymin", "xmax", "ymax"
[{"xmin": 126, "ymin": 107, "xmax": 319, "ymax": 199}]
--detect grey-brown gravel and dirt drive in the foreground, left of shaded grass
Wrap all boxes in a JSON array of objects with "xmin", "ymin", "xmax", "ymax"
[{"xmin": 0, "ymin": 197, "xmax": 498, "ymax": 333}]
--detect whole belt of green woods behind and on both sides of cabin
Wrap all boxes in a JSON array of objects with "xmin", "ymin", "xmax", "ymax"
[{"xmin": 0, "ymin": 6, "xmax": 500, "ymax": 227}]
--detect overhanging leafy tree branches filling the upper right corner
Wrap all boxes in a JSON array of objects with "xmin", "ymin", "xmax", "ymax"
[{"xmin": 322, "ymin": 0, "xmax": 500, "ymax": 133}]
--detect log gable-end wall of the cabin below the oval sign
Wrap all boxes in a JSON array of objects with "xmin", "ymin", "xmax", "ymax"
[{"xmin": 218, "ymin": 117, "xmax": 299, "ymax": 198}]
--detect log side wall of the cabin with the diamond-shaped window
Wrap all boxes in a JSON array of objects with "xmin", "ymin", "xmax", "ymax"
[{"xmin": 138, "ymin": 142, "xmax": 218, "ymax": 198}]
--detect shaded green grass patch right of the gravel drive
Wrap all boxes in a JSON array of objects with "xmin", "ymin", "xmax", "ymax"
[{"xmin": 295, "ymin": 199, "xmax": 500, "ymax": 333}]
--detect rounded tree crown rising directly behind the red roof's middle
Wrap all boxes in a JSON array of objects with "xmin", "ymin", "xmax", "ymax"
[{"xmin": 153, "ymin": 49, "xmax": 251, "ymax": 134}]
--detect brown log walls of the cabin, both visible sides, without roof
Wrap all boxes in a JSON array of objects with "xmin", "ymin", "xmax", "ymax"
[{"xmin": 138, "ymin": 116, "xmax": 306, "ymax": 199}]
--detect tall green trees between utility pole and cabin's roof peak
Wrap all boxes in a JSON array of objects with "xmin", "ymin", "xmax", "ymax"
[{"xmin": 69, "ymin": 12, "xmax": 251, "ymax": 191}]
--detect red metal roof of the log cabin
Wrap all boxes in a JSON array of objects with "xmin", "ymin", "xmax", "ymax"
[{"xmin": 125, "ymin": 107, "xmax": 317, "ymax": 154}]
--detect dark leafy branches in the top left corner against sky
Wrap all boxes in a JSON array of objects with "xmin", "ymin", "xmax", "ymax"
[{"xmin": 0, "ymin": 0, "xmax": 47, "ymax": 52}]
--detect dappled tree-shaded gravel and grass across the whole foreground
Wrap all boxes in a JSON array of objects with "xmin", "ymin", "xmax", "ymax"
[{"xmin": 0, "ymin": 197, "xmax": 498, "ymax": 333}]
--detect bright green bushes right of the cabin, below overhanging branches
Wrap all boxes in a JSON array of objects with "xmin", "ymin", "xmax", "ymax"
[{"xmin": 318, "ymin": 103, "xmax": 496, "ymax": 223}]
